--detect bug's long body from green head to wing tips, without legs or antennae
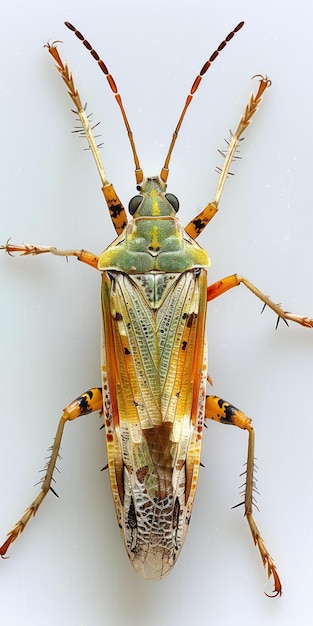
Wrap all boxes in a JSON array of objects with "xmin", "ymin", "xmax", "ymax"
[{"xmin": 99, "ymin": 178, "xmax": 209, "ymax": 578}]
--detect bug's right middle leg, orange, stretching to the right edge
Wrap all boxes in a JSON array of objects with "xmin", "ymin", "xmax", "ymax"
[{"xmin": 207, "ymin": 274, "xmax": 313, "ymax": 328}]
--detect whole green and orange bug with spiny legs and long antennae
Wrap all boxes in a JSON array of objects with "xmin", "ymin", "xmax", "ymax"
[{"xmin": 0, "ymin": 22, "xmax": 313, "ymax": 596}]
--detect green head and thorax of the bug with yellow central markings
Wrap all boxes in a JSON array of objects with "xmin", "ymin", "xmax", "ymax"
[{"xmin": 98, "ymin": 178, "xmax": 210, "ymax": 274}]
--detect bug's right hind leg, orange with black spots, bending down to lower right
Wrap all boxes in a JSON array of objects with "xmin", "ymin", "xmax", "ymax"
[{"xmin": 205, "ymin": 396, "xmax": 282, "ymax": 596}]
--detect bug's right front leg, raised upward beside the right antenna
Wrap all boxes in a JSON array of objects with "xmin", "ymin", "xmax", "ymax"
[{"xmin": 185, "ymin": 76, "xmax": 271, "ymax": 239}]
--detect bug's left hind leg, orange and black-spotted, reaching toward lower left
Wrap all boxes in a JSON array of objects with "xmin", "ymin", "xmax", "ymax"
[{"xmin": 0, "ymin": 387, "xmax": 102, "ymax": 557}]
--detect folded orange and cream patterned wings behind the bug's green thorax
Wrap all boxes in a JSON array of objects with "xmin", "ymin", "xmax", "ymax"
[{"xmin": 102, "ymin": 269, "xmax": 206, "ymax": 575}]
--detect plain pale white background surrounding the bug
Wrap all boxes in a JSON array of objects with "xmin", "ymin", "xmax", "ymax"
[{"xmin": 0, "ymin": 0, "xmax": 313, "ymax": 626}]
